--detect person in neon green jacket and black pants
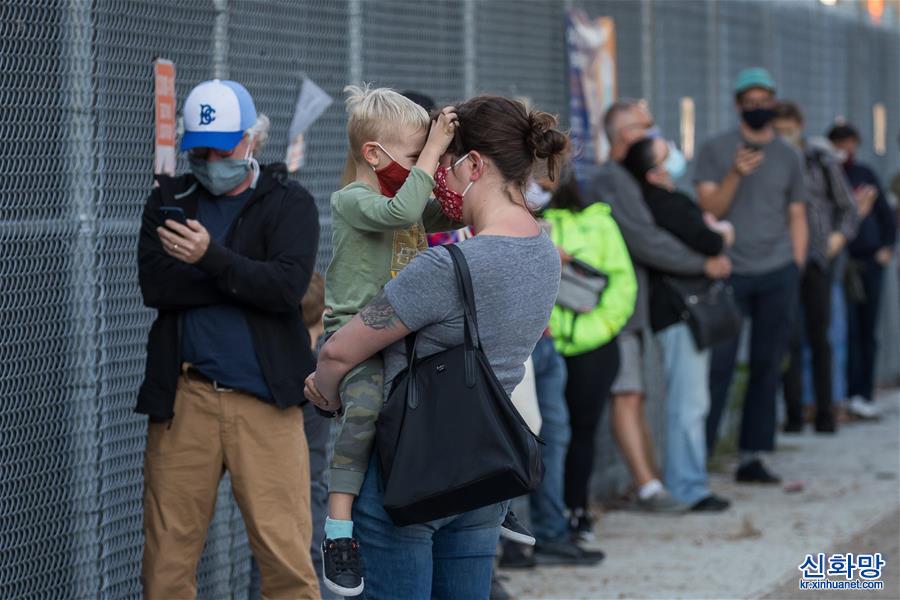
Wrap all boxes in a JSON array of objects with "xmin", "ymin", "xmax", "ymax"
[{"xmin": 543, "ymin": 174, "xmax": 637, "ymax": 538}]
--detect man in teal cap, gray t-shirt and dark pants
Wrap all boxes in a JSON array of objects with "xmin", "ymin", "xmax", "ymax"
[{"xmin": 694, "ymin": 67, "xmax": 808, "ymax": 484}]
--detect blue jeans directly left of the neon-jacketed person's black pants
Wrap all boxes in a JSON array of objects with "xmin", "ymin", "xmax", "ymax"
[{"xmin": 531, "ymin": 337, "xmax": 571, "ymax": 542}]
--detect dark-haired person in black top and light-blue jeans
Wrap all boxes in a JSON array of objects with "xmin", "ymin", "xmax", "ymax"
[{"xmin": 622, "ymin": 138, "xmax": 734, "ymax": 512}]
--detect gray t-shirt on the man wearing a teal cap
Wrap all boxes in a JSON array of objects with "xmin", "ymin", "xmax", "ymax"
[{"xmin": 694, "ymin": 130, "xmax": 807, "ymax": 275}]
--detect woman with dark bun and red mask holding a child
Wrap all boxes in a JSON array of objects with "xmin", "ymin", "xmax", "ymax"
[{"xmin": 307, "ymin": 96, "xmax": 568, "ymax": 598}]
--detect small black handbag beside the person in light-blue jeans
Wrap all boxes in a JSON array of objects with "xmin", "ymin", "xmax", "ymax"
[{"xmin": 663, "ymin": 277, "xmax": 744, "ymax": 350}]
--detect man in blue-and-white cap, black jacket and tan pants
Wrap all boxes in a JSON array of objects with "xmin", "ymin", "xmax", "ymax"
[{"xmin": 136, "ymin": 80, "xmax": 319, "ymax": 599}]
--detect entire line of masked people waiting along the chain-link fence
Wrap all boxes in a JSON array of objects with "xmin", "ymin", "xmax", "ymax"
[{"xmin": 137, "ymin": 63, "xmax": 896, "ymax": 598}]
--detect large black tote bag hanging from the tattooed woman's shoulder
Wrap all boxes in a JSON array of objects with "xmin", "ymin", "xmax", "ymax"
[{"xmin": 375, "ymin": 245, "xmax": 544, "ymax": 527}]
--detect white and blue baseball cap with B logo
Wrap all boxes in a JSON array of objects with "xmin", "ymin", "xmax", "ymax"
[{"xmin": 181, "ymin": 79, "xmax": 256, "ymax": 150}]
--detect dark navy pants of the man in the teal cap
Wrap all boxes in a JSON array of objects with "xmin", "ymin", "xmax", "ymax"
[{"xmin": 706, "ymin": 262, "xmax": 800, "ymax": 454}]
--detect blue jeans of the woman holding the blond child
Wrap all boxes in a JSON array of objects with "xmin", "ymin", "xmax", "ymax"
[{"xmin": 353, "ymin": 455, "xmax": 508, "ymax": 600}]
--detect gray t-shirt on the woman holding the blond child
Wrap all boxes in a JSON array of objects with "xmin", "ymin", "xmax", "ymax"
[{"xmin": 384, "ymin": 233, "xmax": 560, "ymax": 393}]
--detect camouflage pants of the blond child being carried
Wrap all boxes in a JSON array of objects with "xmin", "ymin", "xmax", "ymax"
[{"xmin": 328, "ymin": 355, "xmax": 384, "ymax": 496}]
